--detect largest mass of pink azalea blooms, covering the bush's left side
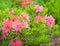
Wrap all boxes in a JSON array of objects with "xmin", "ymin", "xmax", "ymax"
[{"xmin": 2, "ymin": 14, "xmax": 29, "ymax": 36}]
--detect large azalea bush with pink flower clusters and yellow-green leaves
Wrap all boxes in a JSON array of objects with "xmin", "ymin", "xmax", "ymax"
[{"xmin": 0, "ymin": 0, "xmax": 60, "ymax": 46}]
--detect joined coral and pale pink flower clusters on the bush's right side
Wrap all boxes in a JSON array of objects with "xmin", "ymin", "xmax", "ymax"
[{"xmin": 34, "ymin": 16, "xmax": 55, "ymax": 28}]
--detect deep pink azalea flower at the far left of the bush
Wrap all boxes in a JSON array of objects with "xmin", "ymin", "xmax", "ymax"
[{"xmin": 2, "ymin": 20, "xmax": 11, "ymax": 36}]
